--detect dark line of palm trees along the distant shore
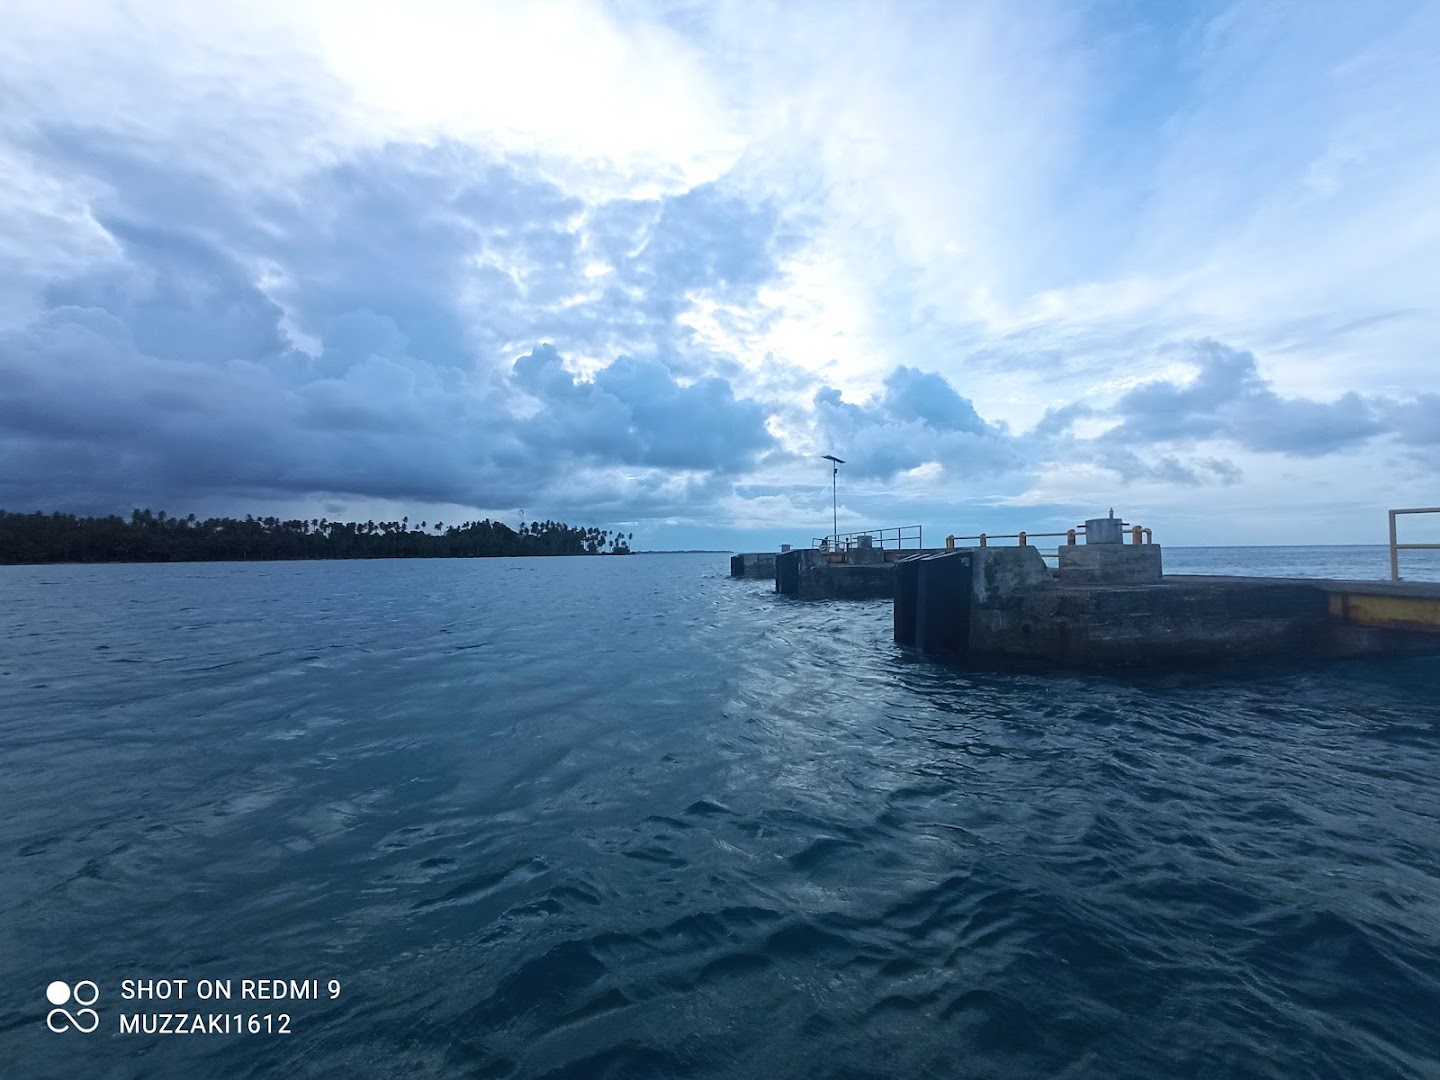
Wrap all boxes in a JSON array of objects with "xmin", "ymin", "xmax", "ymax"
[{"xmin": 0, "ymin": 510, "xmax": 634, "ymax": 563}]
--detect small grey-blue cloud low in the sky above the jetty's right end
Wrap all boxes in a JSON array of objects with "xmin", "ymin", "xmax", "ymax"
[{"xmin": 1113, "ymin": 341, "xmax": 1385, "ymax": 456}]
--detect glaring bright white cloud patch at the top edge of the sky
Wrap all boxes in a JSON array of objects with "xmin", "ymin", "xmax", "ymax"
[{"xmin": 295, "ymin": 0, "xmax": 743, "ymax": 197}]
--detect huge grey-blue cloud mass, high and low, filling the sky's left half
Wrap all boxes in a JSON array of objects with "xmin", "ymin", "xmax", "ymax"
[{"xmin": 0, "ymin": 134, "xmax": 778, "ymax": 513}]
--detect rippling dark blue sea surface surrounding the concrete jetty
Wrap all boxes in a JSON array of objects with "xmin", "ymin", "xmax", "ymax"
[{"xmin": 0, "ymin": 547, "xmax": 1440, "ymax": 1080}]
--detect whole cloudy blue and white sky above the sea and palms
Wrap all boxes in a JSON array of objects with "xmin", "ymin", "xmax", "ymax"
[{"xmin": 0, "ymin": 0, "xmax": 1440, "ymax": 550}]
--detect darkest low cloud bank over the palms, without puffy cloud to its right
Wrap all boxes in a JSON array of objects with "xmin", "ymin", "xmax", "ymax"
[{"xmin": 0, "ymin": 300, "xmax": 513, "ymax": 508}]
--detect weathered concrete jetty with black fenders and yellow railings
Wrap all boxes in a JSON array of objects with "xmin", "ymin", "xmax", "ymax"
[{"xmin": 731, "ymin": 511, "xmax": 1440, "ymax": 668}]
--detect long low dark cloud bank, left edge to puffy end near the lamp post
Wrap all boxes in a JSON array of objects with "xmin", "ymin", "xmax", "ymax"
[{"xmin": 0, "ymin": 296, "xmax": 773, "ymax": 507}]
